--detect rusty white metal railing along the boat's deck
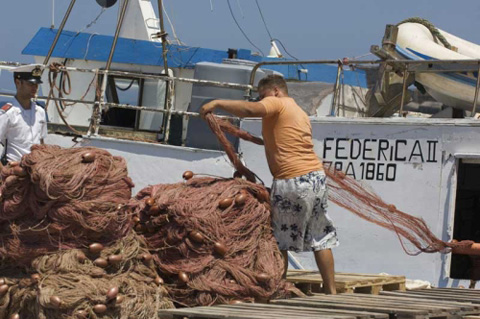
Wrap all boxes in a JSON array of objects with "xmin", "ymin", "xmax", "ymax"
[{"xmin": 0, "ymin": 59, "xmax": 480, "ymax": 145}]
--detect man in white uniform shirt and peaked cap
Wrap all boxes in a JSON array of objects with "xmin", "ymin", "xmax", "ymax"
[{"xmin": 0, "ymin": 64, "xmax": 47, "ymax": 165}]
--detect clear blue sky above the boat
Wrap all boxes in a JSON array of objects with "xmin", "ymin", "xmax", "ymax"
[{"xmin": 0, "ymin": 0, "xmax": 480, "ymax": 94}]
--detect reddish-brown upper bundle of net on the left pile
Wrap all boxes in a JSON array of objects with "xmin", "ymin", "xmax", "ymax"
[{"xmin": 0, "ymin": 145, "xmax": 133, "ymax": 266}]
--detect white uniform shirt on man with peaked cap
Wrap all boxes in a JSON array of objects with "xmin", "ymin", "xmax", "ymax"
[{"xmin": 0, "ymin": 100, "xmax": 47, "ymax": 161}]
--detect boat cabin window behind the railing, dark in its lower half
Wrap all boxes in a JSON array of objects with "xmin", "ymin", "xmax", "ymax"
[{"xmin": 100, "ymin": 76, "xmax": 167, "ymax": 132}]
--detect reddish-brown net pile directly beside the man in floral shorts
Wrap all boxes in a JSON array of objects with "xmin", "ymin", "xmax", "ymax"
[{"xmin": 131, "ymin": 176, "xmax": 301, "ymax": 306}]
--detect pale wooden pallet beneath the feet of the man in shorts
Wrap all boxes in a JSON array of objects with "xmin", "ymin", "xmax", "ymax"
[{"xmin": 287, "ymin": 270, "xmax": 405, "ymax": 295}]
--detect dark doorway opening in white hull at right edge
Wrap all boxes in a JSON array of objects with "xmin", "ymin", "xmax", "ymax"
[{"xmin": 450, "ymin": 157, "xmax": 480, "ymax": 280}]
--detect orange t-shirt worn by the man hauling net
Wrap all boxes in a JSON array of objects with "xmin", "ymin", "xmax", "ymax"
[{"xmin": 260, "ymin": 96, "xmax": 323, "ymax": 179}]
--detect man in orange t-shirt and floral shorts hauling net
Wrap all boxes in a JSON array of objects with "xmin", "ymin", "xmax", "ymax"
[{"xmin": 200, "ymin": 75, "xmax": 338, "ymax": 294}]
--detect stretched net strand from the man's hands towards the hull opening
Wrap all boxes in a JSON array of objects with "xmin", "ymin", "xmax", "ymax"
[{"xmin": 205, "ymin": 114, "xmax": 473, "ymax": 255}]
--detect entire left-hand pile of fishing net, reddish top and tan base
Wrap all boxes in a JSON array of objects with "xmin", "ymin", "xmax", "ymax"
[{"xmin": 0, "ymin": 145, "xmax": 173, "ymax": 319}]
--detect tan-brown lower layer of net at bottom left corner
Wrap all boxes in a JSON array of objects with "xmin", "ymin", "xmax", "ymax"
[{"xmin": 0, "ymin": 231, "xmax": 173, "ymax": 319}]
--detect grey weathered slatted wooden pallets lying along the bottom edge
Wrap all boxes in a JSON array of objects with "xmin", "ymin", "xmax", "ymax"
[{"xmin": 160, "ymin": 289, "xmax": 480, "ymax": 319}]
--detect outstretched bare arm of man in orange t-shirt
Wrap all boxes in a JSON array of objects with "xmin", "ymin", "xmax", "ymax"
[{"xmin": 200, "ymin": 100, "xmax": 267, "ymax": 118}]
